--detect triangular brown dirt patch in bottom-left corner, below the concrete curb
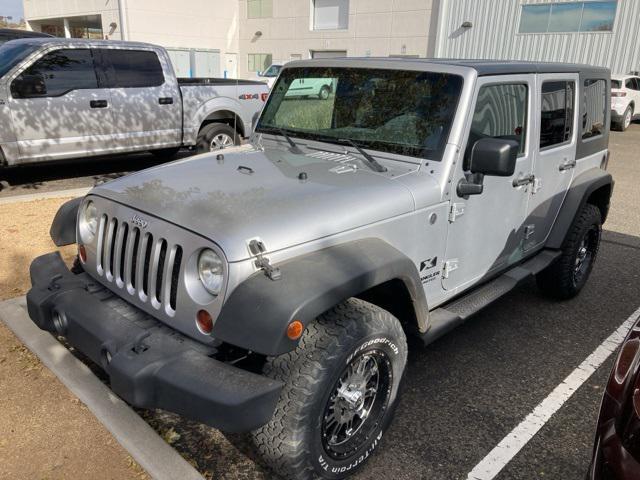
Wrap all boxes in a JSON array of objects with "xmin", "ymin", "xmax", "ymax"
[{"xmin": 0, "ymin": 323, "xmax": 149, "ymax": 480}]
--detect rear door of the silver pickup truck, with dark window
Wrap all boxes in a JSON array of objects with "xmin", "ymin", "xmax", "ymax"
[{"xmin": 98, "ymin": 48, "xmax": 182, "ymax": 150}]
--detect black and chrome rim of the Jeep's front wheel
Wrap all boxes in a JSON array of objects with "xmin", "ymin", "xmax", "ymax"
[{"xmin": 321, "ymin": 350, "xmax": 392, "ymax": 460}]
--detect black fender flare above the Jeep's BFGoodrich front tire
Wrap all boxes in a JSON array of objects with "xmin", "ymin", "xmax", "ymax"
[{"xmin": 212, "ymin": 238, "xmax": 429, "ymax": 355}]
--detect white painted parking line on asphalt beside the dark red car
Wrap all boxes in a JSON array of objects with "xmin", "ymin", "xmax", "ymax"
[{"xmin": 467, "ymin": 308, "xmax": 640, "ymax": 480}]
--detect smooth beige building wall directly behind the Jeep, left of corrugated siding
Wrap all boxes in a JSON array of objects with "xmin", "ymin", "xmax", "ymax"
[{"xmin": 238, "ymin": 0, "xmax": 440, "ymax": 77}]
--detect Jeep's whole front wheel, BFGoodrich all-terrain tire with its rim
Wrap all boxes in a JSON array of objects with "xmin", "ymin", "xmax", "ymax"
[{"xmin": 251, "ymin": 299, "xmax": 407, "ymax": 480}]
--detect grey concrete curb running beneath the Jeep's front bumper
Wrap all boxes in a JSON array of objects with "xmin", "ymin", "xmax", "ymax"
[{"xmin": 0, "ymin": 297, "xmax": 203, "ymax": 480}]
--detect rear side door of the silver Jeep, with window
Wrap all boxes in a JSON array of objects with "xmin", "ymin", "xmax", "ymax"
[{"xmin": 524, "ymin": 74, "xmax": 579, "ymax": 250}]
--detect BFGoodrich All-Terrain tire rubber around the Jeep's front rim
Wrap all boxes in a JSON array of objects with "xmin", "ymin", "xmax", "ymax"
[{"xmin": 250, "ymin": 299, "xmax": 407, "ymax": 480}]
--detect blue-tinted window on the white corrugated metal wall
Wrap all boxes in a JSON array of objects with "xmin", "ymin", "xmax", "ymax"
[{"xmin": 519, "ymin": 0, "xmax": 618, "ymax": 33}]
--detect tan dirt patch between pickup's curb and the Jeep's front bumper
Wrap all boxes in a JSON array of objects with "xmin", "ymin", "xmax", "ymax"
[{"xmin": 0, "ymin": 198, "xmax": 76, "ymax": 300}]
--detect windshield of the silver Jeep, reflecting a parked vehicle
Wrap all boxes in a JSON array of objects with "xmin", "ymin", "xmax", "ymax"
[{"xmin": 256, "ymin": 67, "xmax": 462, "ymax": 160}]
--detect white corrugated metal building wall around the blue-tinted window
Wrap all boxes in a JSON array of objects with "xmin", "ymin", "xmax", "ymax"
[{"xmin": 436, "ymin": 0, "xmax": 640, "ymax": 73}]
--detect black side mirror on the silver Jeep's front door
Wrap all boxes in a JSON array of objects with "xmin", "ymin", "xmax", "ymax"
[{"xmin": 469, "ymin": 138, "xmax": 520, "ymax": 177}]
